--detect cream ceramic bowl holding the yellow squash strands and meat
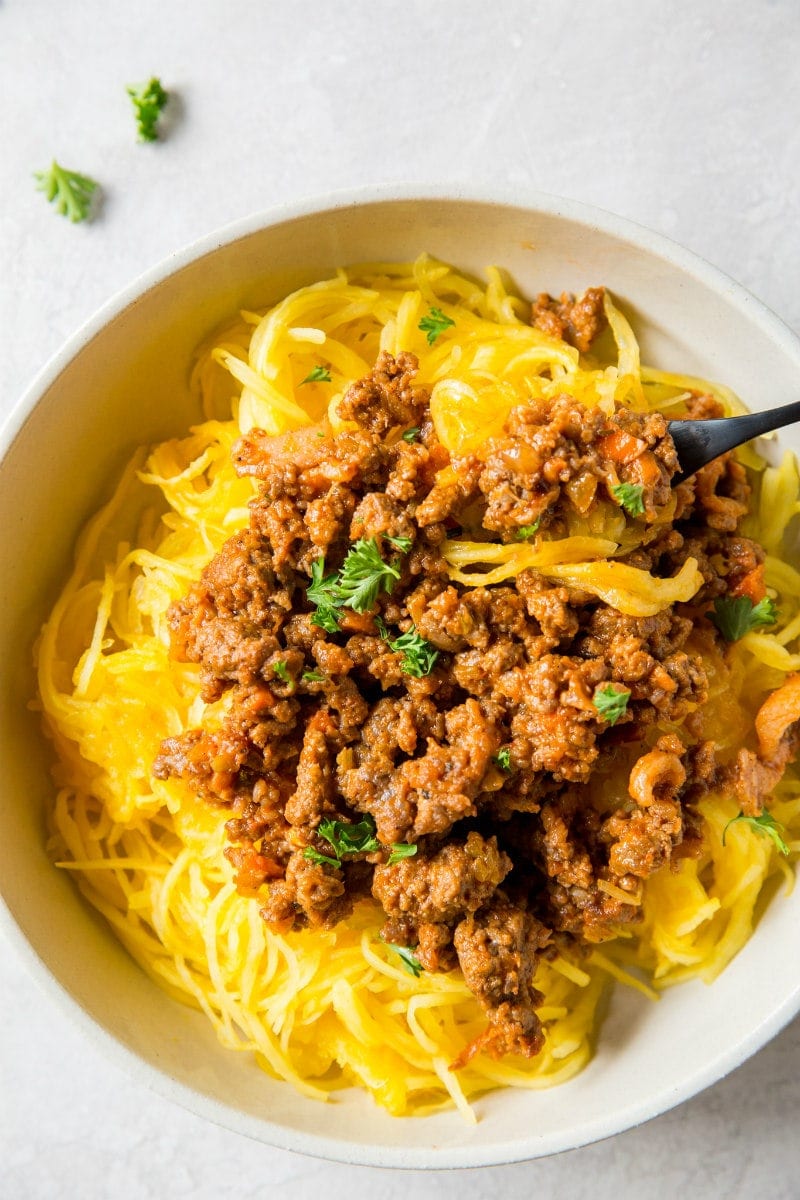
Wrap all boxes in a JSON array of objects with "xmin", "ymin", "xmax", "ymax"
[{"xmin": 0, "ymin": 188, "xmax": 800, "ymax": 1168}]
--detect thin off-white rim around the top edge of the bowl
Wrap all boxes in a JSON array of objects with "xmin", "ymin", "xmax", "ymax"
[{"xmin": 0, "ymin": 182, "xmax": 800, "ymax": 1170}]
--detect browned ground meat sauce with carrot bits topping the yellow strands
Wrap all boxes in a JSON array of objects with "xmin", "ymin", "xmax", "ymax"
[{"xmin": 155, "ymin": 309, "xmax": 777, "ymax": 1067}]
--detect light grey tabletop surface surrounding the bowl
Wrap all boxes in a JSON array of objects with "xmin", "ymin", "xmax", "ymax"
[{"xmin": 0, "ymin": 0, "xmax": 800, "ymax": 1200}]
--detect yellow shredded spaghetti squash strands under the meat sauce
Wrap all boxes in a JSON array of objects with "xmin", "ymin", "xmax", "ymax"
[{"xmin": 37, "ymin": 257, "xmax": 800, "ymax": 1120}]
